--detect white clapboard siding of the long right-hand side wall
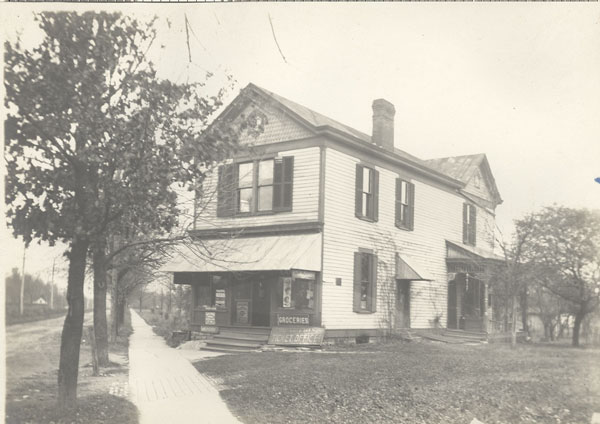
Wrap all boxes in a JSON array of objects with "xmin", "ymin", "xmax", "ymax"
[{"xmin": 322, "ymin": 148, "xmax": 488, "ymax": 329}]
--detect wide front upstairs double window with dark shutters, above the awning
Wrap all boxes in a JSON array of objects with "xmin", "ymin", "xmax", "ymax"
[{"xmin": 217, "ymin": 156, "xmax": 294, "ymax": 217}]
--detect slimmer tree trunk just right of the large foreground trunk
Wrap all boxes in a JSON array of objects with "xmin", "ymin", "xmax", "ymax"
[{"xmin": 92, "ymin": 244, "xmax": 108, "ymax": 367}]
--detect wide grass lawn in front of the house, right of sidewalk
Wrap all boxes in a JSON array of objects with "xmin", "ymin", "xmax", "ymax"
[{"xmin": 195, "ymin": 342, "xmax": 600, "ymax": 424}]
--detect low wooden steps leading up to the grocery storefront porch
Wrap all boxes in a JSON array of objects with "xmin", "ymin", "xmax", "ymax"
[{"xmin": 202, "ymin": 327, "xmax": 271, "ymax": 353}]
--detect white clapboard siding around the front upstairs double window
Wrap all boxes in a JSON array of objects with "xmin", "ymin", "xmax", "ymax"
[{"xmin": 195, "ymin": 147, "xmax": 320, "ymax": 230}]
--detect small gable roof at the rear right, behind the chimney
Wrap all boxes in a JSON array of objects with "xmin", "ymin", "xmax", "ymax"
[{"xmin": 425, "ymin": 153, "xmax": 502, "ymax": 204}]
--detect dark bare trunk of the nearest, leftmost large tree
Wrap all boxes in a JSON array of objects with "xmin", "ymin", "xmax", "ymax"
[{"xmin": 58, "ymin": 236, "xmax": 89, "ymax": 409}]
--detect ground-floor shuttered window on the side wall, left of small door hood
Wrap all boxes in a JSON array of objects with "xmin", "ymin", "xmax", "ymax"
[{"xmin": 353, "ymin": 251, "xmax": 377, "ymax": 313}]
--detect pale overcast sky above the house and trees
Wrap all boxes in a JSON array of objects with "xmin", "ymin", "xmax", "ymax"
[{"xmin": 0, "ymin": 3, "xmax": 600, "ymax": 288}]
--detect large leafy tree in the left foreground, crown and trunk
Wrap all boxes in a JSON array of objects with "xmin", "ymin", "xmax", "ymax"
[{"xmin": 5, "ymin": 12, "xmax": 235, "ymax": 407}]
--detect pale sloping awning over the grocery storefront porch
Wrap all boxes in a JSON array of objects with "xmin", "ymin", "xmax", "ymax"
[{"xmin": 161, "ymin": 233, "xmax": 321, "ymax": 272}]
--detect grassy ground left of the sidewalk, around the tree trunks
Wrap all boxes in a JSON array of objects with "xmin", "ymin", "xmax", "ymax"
[{"xmin": 5, "ymin": 311, "xmax": 138, "ymax": 424}]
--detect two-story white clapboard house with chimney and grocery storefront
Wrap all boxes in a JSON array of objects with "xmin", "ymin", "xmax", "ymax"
[{"xmin": 165, "ymin": 84, "xmax": 502, "ymax": 348}]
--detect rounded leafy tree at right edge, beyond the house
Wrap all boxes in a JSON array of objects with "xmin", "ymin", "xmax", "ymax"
[{"xmin": 517, "ymin": 206, "xmax": 600, "ymax": 346}]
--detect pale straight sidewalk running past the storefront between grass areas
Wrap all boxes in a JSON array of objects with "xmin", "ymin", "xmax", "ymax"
[{"xmin": 129, "ymin": 310, "xmax": 240, "ymax": 424}]
